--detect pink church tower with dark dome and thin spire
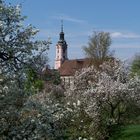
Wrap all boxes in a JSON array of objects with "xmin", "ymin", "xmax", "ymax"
[{"xmin": 55, "ymin": 21, "xmax": 68, "ymax": 69}]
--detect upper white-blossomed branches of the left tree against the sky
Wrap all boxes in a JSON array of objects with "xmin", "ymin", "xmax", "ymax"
[{"xmin": 0, "ymin": 1, "xmax": 49, "ymax": 75}]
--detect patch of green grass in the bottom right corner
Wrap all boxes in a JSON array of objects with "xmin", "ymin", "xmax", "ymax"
[{"xmin": 109, "ymin": 124, "xmax": 140, "ymax": 140}]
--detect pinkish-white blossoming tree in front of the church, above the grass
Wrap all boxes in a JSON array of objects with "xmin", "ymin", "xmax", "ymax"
[{"xmin": 66, "ymin": 61, "xmax": 140, "ymax": 140}]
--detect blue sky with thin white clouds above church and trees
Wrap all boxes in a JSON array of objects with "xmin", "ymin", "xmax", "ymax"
[{"xmin": 5, "ymin": 0, "xmax": 140, "ymax": 67}]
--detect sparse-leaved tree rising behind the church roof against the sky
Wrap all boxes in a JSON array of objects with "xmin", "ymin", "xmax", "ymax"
[{"xmin": 83, "ymin": 32, "xmax": 112, "ymax": 66}]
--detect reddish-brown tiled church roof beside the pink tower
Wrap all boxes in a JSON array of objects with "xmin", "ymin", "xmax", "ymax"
[{"xmin": 58, "ymin": 58, "xmax": 91, "ymax": 76}]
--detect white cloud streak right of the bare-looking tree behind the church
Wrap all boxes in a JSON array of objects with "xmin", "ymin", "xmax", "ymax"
[{"xmin": 110, "ymin": 32, "xmax": 140, "ymax": 39}]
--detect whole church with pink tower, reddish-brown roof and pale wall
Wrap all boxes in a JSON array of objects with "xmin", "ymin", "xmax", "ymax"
[{"xmin": 55, "ymin": 22, "xmax": 91, "ymax": 86}]
